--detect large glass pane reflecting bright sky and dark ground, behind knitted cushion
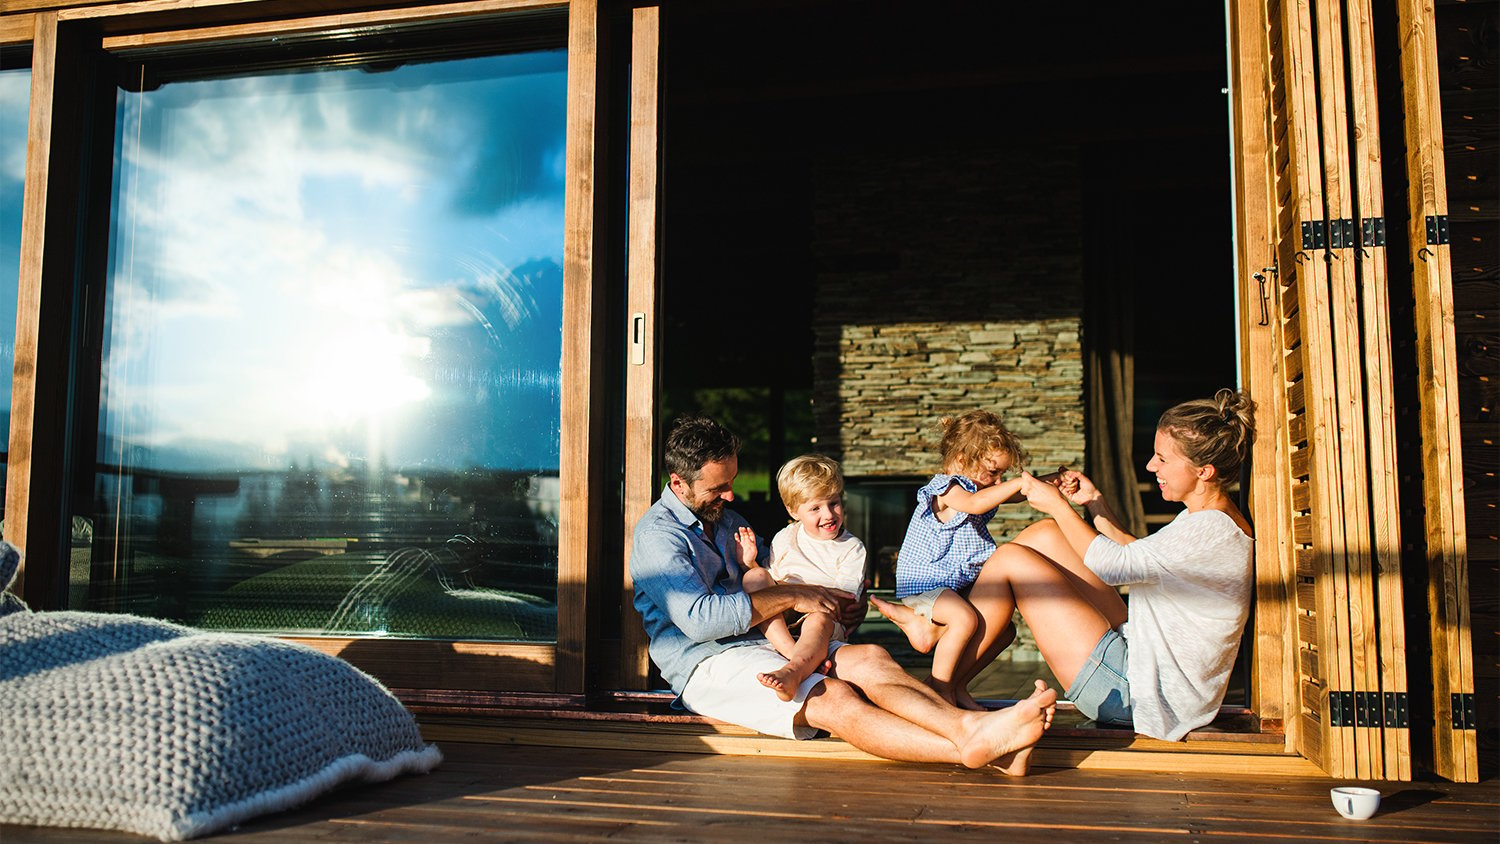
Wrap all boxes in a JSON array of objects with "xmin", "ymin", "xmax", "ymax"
[{"xmin": 72, "ymin": 41, "xmax": 566, "ymax": 642}]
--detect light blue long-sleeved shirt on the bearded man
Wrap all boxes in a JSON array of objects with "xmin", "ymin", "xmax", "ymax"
[{"xmin": 630, "ymin": 486, "xmax": 767, "ymax": 694}]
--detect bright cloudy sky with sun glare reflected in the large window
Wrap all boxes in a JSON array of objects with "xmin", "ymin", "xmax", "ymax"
[{"xmin": 101, "ymin": 49, "xmax": 566, "ymax": 472}]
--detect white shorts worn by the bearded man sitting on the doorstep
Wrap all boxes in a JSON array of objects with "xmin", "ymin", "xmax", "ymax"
[{"xmin": 681, "ymin": 642, "xmax": 843, "ymax": 739}]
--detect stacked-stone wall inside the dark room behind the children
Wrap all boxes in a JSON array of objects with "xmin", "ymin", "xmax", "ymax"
[{"xmin": 813, "ymin": 148, "xmax": 1085, "ymax": 537}]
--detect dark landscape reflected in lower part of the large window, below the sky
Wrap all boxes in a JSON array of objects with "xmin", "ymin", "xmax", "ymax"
[{"xmin": 92, "ymin": 466, "xmax": 558, "ymax": 642}]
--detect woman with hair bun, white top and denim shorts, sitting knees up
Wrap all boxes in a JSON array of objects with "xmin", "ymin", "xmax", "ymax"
[{"xmin": 960, "ymin": 390, "xmax": 1256, "ymax": 741}]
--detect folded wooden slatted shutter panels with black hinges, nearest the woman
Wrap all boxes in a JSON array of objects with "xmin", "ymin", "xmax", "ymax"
[{"xmin": 1266, "ymin": 0, "xmax": 1412, "ymax": 780}]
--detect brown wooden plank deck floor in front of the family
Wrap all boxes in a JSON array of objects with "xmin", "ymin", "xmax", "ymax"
[{"xmin": 0, "ymin": 742, "xmax": 1500, "ymax": 844}]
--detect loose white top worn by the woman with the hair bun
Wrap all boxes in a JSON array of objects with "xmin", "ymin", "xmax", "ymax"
[{"xmin": 1083, "ymin": 510, "xmax": 1254, "ymax": 741}]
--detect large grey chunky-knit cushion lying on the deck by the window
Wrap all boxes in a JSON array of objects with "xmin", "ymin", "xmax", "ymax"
[{"xmin": 0, "ymin": 543, "xmax": 441, "ymax": 841}]
